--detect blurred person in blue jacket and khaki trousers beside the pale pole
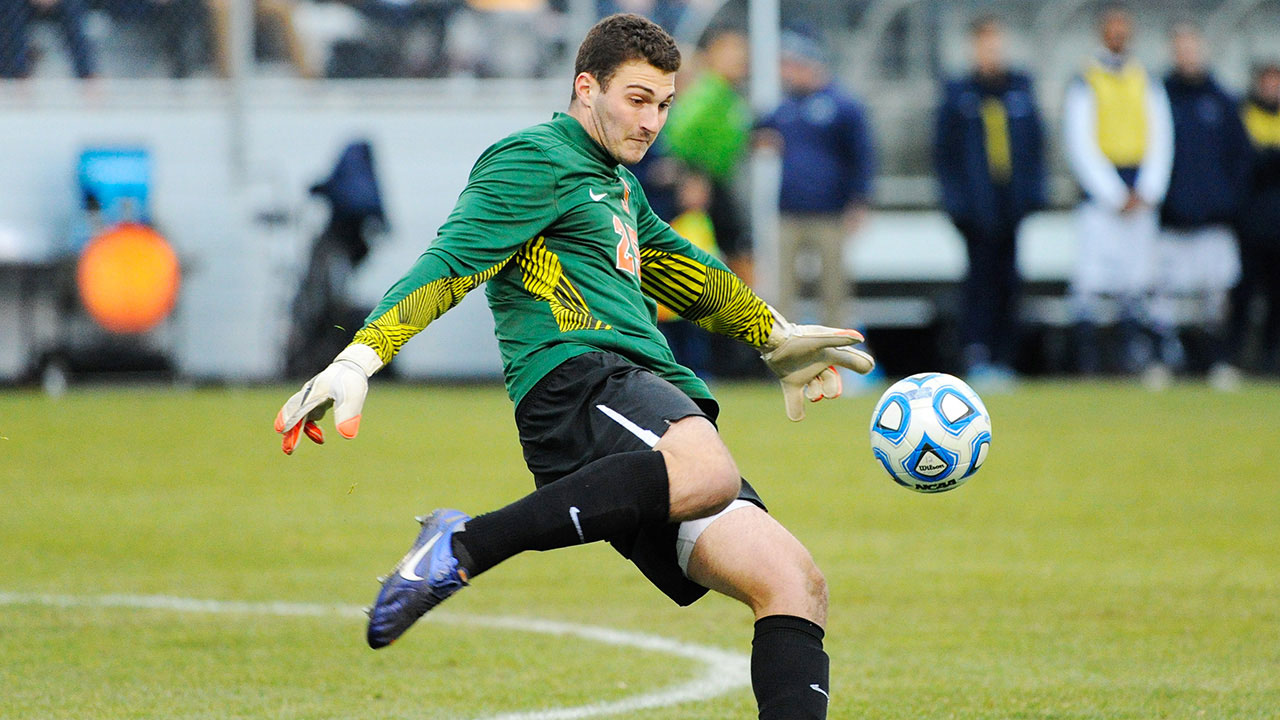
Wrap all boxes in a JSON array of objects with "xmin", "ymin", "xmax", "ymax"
[{"xmin": 758, "ymin": 31, "xmax": 874, "ymax": 327}]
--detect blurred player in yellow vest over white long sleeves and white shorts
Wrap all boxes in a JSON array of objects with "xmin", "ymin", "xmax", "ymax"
[{"xmin": 1062, "ymin": 5, "xmax": 1174, "ymax": 374}]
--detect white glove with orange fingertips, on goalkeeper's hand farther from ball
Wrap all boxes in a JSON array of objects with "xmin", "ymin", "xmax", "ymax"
[{"xmin": 275, "ymin": 343, "xmax": 383, "ymax": 455}]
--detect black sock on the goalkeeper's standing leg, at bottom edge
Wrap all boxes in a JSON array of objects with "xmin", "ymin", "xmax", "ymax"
[{"xmin": 751, "ymin": 615, "xmax": 831, "ymax": 720}]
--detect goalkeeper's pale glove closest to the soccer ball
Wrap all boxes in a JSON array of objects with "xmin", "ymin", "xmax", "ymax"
[{"xmin": 762, "ymin": 307, "xmax": 876, "ymax": 421}]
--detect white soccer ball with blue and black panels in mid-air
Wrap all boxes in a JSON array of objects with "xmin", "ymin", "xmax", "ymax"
[{"xmin": 872, "ymin": 373, "xmax": 991, "ymax": 492}]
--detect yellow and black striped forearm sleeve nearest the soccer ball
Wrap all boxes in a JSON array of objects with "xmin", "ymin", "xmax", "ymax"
[{"xmin": 640, "ymin": 247, "xmax": 773, "ymax": 347}]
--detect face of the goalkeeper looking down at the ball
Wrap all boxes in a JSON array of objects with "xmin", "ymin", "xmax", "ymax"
[{"xmin": 584, "ymin": 60, "xmax": 676, "ymax": 165}]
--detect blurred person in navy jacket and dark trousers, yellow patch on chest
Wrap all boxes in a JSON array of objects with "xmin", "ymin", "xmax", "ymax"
[{"xmin": 933, "ymin": 15, "xmax": 1044, "ymax": 387}]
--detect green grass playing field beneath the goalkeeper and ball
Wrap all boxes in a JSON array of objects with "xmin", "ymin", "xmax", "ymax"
[{"xmin": 0, "ymin": 383, "xmax": 1280, "ymax": 720}]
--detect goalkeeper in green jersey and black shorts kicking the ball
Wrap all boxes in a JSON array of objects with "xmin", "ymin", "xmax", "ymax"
[{"xmin": 275, "ymin": 14, "xmax": 873, "ymax": 720}]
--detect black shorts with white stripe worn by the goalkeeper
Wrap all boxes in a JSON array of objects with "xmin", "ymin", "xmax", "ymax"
[{"xmin": 516, "ymin": 352, "xmax": 764, "ymax": 605}]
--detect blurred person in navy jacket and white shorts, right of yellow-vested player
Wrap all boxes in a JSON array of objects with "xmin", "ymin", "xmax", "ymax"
[{"xmin": 1147, "ymin": 22, "xmax": 1249, "ymax": 387}]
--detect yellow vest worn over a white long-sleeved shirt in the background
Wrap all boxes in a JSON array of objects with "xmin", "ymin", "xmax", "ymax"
[{"xmin": 1084, "ymin": 60, "xmax": 1148, "ymax": 168}]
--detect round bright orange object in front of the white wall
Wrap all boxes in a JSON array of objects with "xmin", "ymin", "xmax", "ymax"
[{"xmin": 76, "ymin": 223, "xmax": 182, "ymax": 333}]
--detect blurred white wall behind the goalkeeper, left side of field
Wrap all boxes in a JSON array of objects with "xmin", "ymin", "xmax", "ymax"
[{"xmin": 0, "ymin": 82, "xmax": 564, "ymax": 379}]
